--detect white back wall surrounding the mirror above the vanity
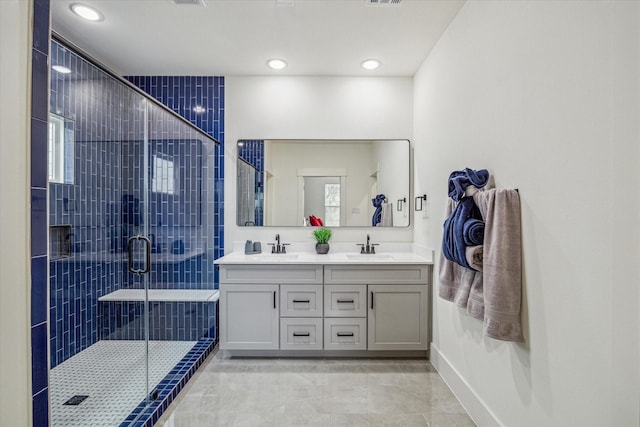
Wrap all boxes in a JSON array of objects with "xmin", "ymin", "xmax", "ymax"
[{"xmin": 225, "ymin": 76, "xmax": 413, "ymax": 252}]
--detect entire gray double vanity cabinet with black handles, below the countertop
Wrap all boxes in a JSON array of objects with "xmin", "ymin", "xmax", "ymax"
[{"xmin": 220, "ymin": 262, "xmax": 432, "ymax": 355}]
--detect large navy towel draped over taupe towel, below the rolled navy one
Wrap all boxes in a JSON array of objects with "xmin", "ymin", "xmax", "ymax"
[{"xmin": 442, "ymin": 197, "xmax": 482, "ymax": 270}]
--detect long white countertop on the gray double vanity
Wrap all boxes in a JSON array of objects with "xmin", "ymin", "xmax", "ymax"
[{"xmin": 214, "ymin": 244, "xmax": 433, "ymax": 265}]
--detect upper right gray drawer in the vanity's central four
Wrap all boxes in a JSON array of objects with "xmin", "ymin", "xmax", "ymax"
[{"xmin": 324, "ymin": 285, "xmax": 367, "ymax": 317}]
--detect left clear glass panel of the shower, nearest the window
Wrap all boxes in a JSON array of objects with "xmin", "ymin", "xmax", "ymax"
[{"xmin": 49, "ymin": 42, "xmax": 148, "ymax": 427}]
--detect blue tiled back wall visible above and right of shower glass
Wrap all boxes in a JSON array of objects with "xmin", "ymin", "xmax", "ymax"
[{"xmin": 126, "ymin": 76, "xmax": 224, "ymax": 288}]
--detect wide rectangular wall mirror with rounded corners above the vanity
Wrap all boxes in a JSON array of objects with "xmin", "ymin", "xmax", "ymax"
[{"xmin": 236, "ymin": 139, "xmax": 409, "ymax": 227}]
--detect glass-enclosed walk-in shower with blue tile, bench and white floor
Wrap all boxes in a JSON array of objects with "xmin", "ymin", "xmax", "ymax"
[{"xmin": 47, "ymin": 41, "xmax": 219, "ymax": 426}]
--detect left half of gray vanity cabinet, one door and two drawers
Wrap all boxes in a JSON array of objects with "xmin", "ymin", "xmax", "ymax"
[{"xmin": 220, "ymin": 265, "xmax": 323, "ymax": 350}]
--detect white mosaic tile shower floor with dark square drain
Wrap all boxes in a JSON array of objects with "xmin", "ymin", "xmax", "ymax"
[{"xmin": 50, "ymin": 341, "xmax": 196, "ymax": 427}]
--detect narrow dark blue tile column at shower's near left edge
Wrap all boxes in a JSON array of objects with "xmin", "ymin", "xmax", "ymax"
[{"xmin": 30, "ymin": 0, "xmax": 49, "ymax": 427}]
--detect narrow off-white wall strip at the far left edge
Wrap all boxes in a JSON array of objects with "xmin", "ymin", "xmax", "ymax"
[{"xmin": 0, "ymin": 0, "xmax": 32, "ymax": 426}]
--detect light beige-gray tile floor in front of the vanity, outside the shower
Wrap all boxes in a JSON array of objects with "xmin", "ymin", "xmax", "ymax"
[{"xmin": 155, "ymin": 351, "xmax": 475, "ymax": 427}]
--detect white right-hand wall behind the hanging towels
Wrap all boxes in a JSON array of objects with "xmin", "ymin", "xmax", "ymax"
[{"xmin": 414, "ymin": 1, "xmax": 640, "ymax": 427}]
